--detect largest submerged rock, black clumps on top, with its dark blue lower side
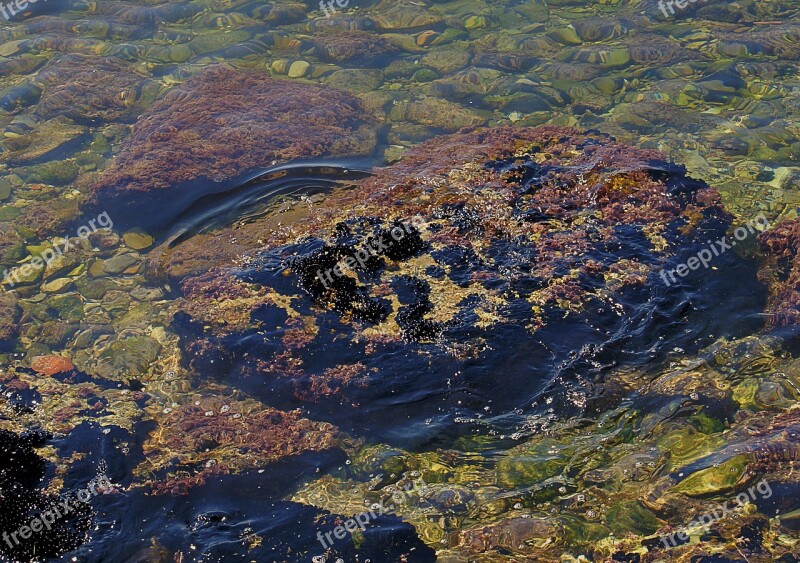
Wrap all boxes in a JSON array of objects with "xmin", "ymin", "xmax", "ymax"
[{"xmin": 169, "ymin": 127, "xmax": 761, "ymax": 440}]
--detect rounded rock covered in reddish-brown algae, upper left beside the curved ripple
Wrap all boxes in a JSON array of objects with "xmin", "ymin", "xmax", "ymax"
[{"xmin": 90, "ymin": 67, "xmax": 376, "ymax": 228}]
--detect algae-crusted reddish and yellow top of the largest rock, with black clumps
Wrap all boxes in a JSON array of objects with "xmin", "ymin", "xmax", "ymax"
[{"xmin": 166, "ymin": 127, "xmax": 754, "ymax": 418}]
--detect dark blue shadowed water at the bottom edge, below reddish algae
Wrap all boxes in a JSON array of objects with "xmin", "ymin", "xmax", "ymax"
[{"xmin": 65, "ymin": 452, "xmax": 435, "ymax": 563}]
